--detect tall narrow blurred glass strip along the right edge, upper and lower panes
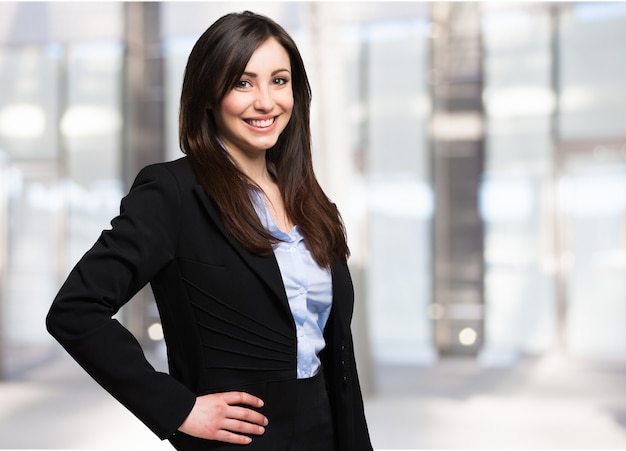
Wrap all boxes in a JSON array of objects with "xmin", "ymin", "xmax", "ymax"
[{"xmin": 557, "ymin": 2, "xmax": 626, "ymax": 358}]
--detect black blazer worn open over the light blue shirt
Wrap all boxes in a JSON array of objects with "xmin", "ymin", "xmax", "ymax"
[{"xmin": 47, "ymin": 158, "xmax": 372, "ymax": 451}]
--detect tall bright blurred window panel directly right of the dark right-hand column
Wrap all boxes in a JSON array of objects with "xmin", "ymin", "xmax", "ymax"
[{"xmin": 480, "ymin": 3, "xmax": 556, "ymax": 359}]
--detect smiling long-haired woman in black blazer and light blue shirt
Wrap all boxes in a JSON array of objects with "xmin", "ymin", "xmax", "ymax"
[{"xmin": 47, "ymin": 12, "xmax": 372, "ymax": 451}]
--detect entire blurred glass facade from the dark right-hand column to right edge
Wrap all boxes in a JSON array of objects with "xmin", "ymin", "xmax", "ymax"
[{"xmin": 481, "ymin": 2, "xmax": 626, "ymax": 359}]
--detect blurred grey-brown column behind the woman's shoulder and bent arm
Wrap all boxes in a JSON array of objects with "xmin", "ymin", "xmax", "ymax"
[{"xmin": 122, "ymin": 2, "xmax": 165, "ymax": 344}]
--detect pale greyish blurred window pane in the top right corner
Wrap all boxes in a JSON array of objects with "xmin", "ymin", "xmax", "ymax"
[{"xmin": 559, "ymin": 2, "xmax": 626, "ymax": 140}]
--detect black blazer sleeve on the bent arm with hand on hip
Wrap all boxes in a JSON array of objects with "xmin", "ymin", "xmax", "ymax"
[{"xmin": 46, "ymin": 165, "xmax": 196, "ymax": 439}]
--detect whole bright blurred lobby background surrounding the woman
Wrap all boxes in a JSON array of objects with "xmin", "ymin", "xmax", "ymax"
[{"xmin": 0, "ymin": 1, "xmax": 626, "ymax": 449}]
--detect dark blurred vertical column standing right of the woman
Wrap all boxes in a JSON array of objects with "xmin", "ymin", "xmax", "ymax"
[{"xmin": 431, "ymin": 2, "xmax": 484, "ymax": 355}]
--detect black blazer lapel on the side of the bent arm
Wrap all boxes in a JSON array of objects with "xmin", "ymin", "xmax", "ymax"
[{"xmin": 193, "ymin": 185, "xmax": 291, "ymax": 314}]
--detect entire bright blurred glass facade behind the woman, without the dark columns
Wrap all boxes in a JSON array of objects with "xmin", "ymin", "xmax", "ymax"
[{"xmin": 0, "ymin": 2, "xmax": 626, "ymax": 370}]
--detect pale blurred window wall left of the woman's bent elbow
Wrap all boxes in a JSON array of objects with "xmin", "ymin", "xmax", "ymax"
[{"xmin": 0, "ymin": 2, "xmax": 124, "ymax": 345}]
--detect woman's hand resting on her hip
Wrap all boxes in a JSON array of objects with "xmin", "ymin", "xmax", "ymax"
[{"xmin": 178, "ymin": 392, "xmax": 268, "ymax": 445}]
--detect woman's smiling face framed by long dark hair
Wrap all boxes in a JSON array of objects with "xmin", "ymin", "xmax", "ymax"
[{"xmin": 215, "ymin": 38, "xmax": 293, "ymax": 161}]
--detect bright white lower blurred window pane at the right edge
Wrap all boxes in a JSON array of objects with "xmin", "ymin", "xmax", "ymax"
[{"xmin": 559, "ymin": 154, "xmax": 626, "ymax": 359}]
